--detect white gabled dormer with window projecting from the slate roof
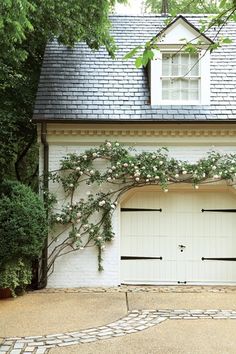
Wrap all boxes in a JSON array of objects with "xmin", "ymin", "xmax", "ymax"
[{"xmin": 150, "ymin": 16, "xmax": 213, "ymax": 106}]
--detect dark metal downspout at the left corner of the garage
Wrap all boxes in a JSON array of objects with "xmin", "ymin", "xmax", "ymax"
[{"xmin": 38, "ymin": 122, "xmax": 49, "ymax": 289}]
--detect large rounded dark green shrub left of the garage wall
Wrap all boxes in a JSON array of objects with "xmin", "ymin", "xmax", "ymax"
[{"xmin": 0, "ymin": 181, "xmax": 47, "ymax": 268}]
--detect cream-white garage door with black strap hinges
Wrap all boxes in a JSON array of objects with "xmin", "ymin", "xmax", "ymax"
[{"xmin": 121, "ymin": 190, "xmax": 236, "ymax": 284}]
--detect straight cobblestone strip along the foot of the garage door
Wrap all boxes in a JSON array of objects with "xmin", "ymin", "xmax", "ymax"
[{"xmin": 31, "ymin": 285, "xmax": 236, "ymax": 294}]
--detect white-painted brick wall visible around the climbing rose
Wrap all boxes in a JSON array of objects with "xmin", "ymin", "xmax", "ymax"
[{"xmin": 40, "ymin": 128, "xmax": 236, "ymax": 287}]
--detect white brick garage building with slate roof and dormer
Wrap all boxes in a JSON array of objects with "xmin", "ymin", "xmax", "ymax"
[{"xmin": 33, "ymin": 15, "xmax": 236, "ymax": 287}]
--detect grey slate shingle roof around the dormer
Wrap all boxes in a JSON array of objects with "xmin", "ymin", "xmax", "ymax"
[{"xmin": 33, "ymin": 15, "xmax": 236, "ymax": 122}]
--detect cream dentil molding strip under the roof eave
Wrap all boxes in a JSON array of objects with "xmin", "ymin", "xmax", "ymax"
[{"xmin": 48, "ymin": 128, "xmax": 236, "ymax": 137}]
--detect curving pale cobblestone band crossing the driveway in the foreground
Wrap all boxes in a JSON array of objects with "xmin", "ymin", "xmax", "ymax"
[{"xmin": 0, "ymin": 309, "xmax": 236, "ymax": 354}]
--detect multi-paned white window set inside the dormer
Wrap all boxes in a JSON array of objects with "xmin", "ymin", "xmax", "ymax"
[{"xmin": 161, "ymin": 53, "xmax": 200, "ymax": 102}]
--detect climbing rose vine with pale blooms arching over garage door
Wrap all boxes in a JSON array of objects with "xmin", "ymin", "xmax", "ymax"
[{"xmin": 46, "ymin": 141, "xmax": 236, "ymax": 272}]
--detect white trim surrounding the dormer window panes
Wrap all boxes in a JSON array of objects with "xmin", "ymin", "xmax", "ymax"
[{"xmin": 150, "ymin": 48, "xmax": 210, "ymax": 106}]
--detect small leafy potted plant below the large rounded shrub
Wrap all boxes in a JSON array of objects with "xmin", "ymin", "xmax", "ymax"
[{"xmin": 0, "ymin": 259, "xmax": 32, "ymax": 296}]
